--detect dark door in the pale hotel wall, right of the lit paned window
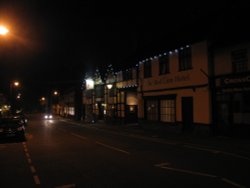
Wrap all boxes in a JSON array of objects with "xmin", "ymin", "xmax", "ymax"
[{"xmin": 181, "ymin": 97, "xmax": 194, "ymax": 132}]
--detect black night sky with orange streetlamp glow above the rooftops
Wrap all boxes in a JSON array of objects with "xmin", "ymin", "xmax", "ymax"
[{"xmin": 0, "ymin": 0, "xmax": 250, "ymax": 110}]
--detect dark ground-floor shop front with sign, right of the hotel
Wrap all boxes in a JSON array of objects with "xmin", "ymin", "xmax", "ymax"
[{"xmin": 215, "ymin": 72, "xmax": 250, "ymax": 135}]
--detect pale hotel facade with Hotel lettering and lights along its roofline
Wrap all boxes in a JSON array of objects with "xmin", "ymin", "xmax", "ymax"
[{"xmin": 138, "ymin": 41, "xmax": 211, "ymax": 134}]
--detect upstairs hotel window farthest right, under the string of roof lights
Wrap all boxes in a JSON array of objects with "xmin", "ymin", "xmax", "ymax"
[{"xmin": 179, "ymin": 48, "xmax": 192, "ymax": 71}]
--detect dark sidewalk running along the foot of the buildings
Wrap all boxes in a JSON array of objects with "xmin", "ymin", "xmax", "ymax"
[{"xmin": 66, "ymin": 117, "xmax": 250, "ymax": 156}]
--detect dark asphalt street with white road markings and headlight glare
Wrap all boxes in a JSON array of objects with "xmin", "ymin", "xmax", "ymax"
[{"xmin": 0, "ymin": 115, "xmax": 250, "ymax": 188}]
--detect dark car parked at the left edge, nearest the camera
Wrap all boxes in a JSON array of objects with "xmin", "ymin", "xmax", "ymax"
[{"xmin": 0, "ymin": 115, "xmax": 26, "ymax": 139}]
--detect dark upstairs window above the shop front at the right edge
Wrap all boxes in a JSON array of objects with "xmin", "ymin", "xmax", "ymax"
[{"xmin": 231, "ymin": 49, "xmax": 248, "ymax": 73}]
